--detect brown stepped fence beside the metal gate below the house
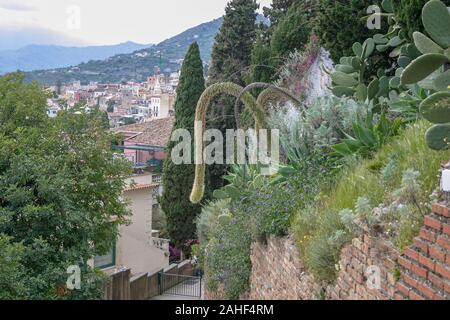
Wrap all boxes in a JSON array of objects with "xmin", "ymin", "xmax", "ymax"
[{"xmin": 104, "ymin": 260, "xmax": 194, "ymax": 300}]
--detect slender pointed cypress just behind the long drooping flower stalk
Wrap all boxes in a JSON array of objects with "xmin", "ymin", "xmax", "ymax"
[{"xmin": 160, "ymin": 43, "xmax": 205, "ymax": 248}]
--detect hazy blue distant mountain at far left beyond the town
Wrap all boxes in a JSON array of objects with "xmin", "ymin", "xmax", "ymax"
[{"xmin": 0, "ymin": 42, "xmax": 152, "ymax": 74}]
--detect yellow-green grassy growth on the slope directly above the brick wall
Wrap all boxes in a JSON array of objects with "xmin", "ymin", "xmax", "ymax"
[{"xmin": 292, "ymin": 122, "xmax": 448, "ymax": 281}]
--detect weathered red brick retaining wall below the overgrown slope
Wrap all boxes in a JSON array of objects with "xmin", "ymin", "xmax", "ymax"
[{"xmin": 206, "ymin": 204, "xmax": 450, "ymax": 300}]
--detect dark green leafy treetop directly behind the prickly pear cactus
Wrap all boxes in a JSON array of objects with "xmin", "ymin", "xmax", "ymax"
[{"xmin": 314, "ymin": 0, "xmax": 387, "ymax": 62}]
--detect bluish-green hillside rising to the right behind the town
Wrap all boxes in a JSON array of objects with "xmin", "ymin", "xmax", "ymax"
[{"xmin": 27, "ymin": 18, "xmax": 222, "ymax": 85}]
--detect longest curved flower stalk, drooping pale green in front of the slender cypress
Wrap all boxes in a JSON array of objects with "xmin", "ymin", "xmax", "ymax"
[{"xmin": 190, "ymin": 82, "xmax": 260, "ymax": 203}]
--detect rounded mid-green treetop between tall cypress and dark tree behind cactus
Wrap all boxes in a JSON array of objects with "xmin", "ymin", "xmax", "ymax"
[{"xmin": 271, "ymin": 1, "xmax": 313, "ymax": 57}]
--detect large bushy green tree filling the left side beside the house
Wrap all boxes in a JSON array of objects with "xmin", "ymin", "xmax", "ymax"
[{"xmin": 0, "ymin": 74, "xmax": 131, "ymax": 299}]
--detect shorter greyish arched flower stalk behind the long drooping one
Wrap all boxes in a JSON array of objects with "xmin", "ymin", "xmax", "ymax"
[{"xmin": 234, "ymin": 82, "xmax": 302, "ymax": 128}]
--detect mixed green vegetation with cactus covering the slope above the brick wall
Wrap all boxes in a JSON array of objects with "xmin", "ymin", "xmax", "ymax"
[{"xmin": 198, "ymin": 0, "xmax": 450, "ymax": 298}]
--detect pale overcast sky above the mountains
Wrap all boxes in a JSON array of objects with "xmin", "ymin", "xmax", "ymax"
[{"xmin": 0, "ymin": 0, "xmax": 271, "ymax": 44}]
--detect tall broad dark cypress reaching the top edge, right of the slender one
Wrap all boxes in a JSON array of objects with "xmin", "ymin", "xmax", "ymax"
[{"xmin": 206, "ymin": 0, "xmax": 259, "ymax": 196}]
